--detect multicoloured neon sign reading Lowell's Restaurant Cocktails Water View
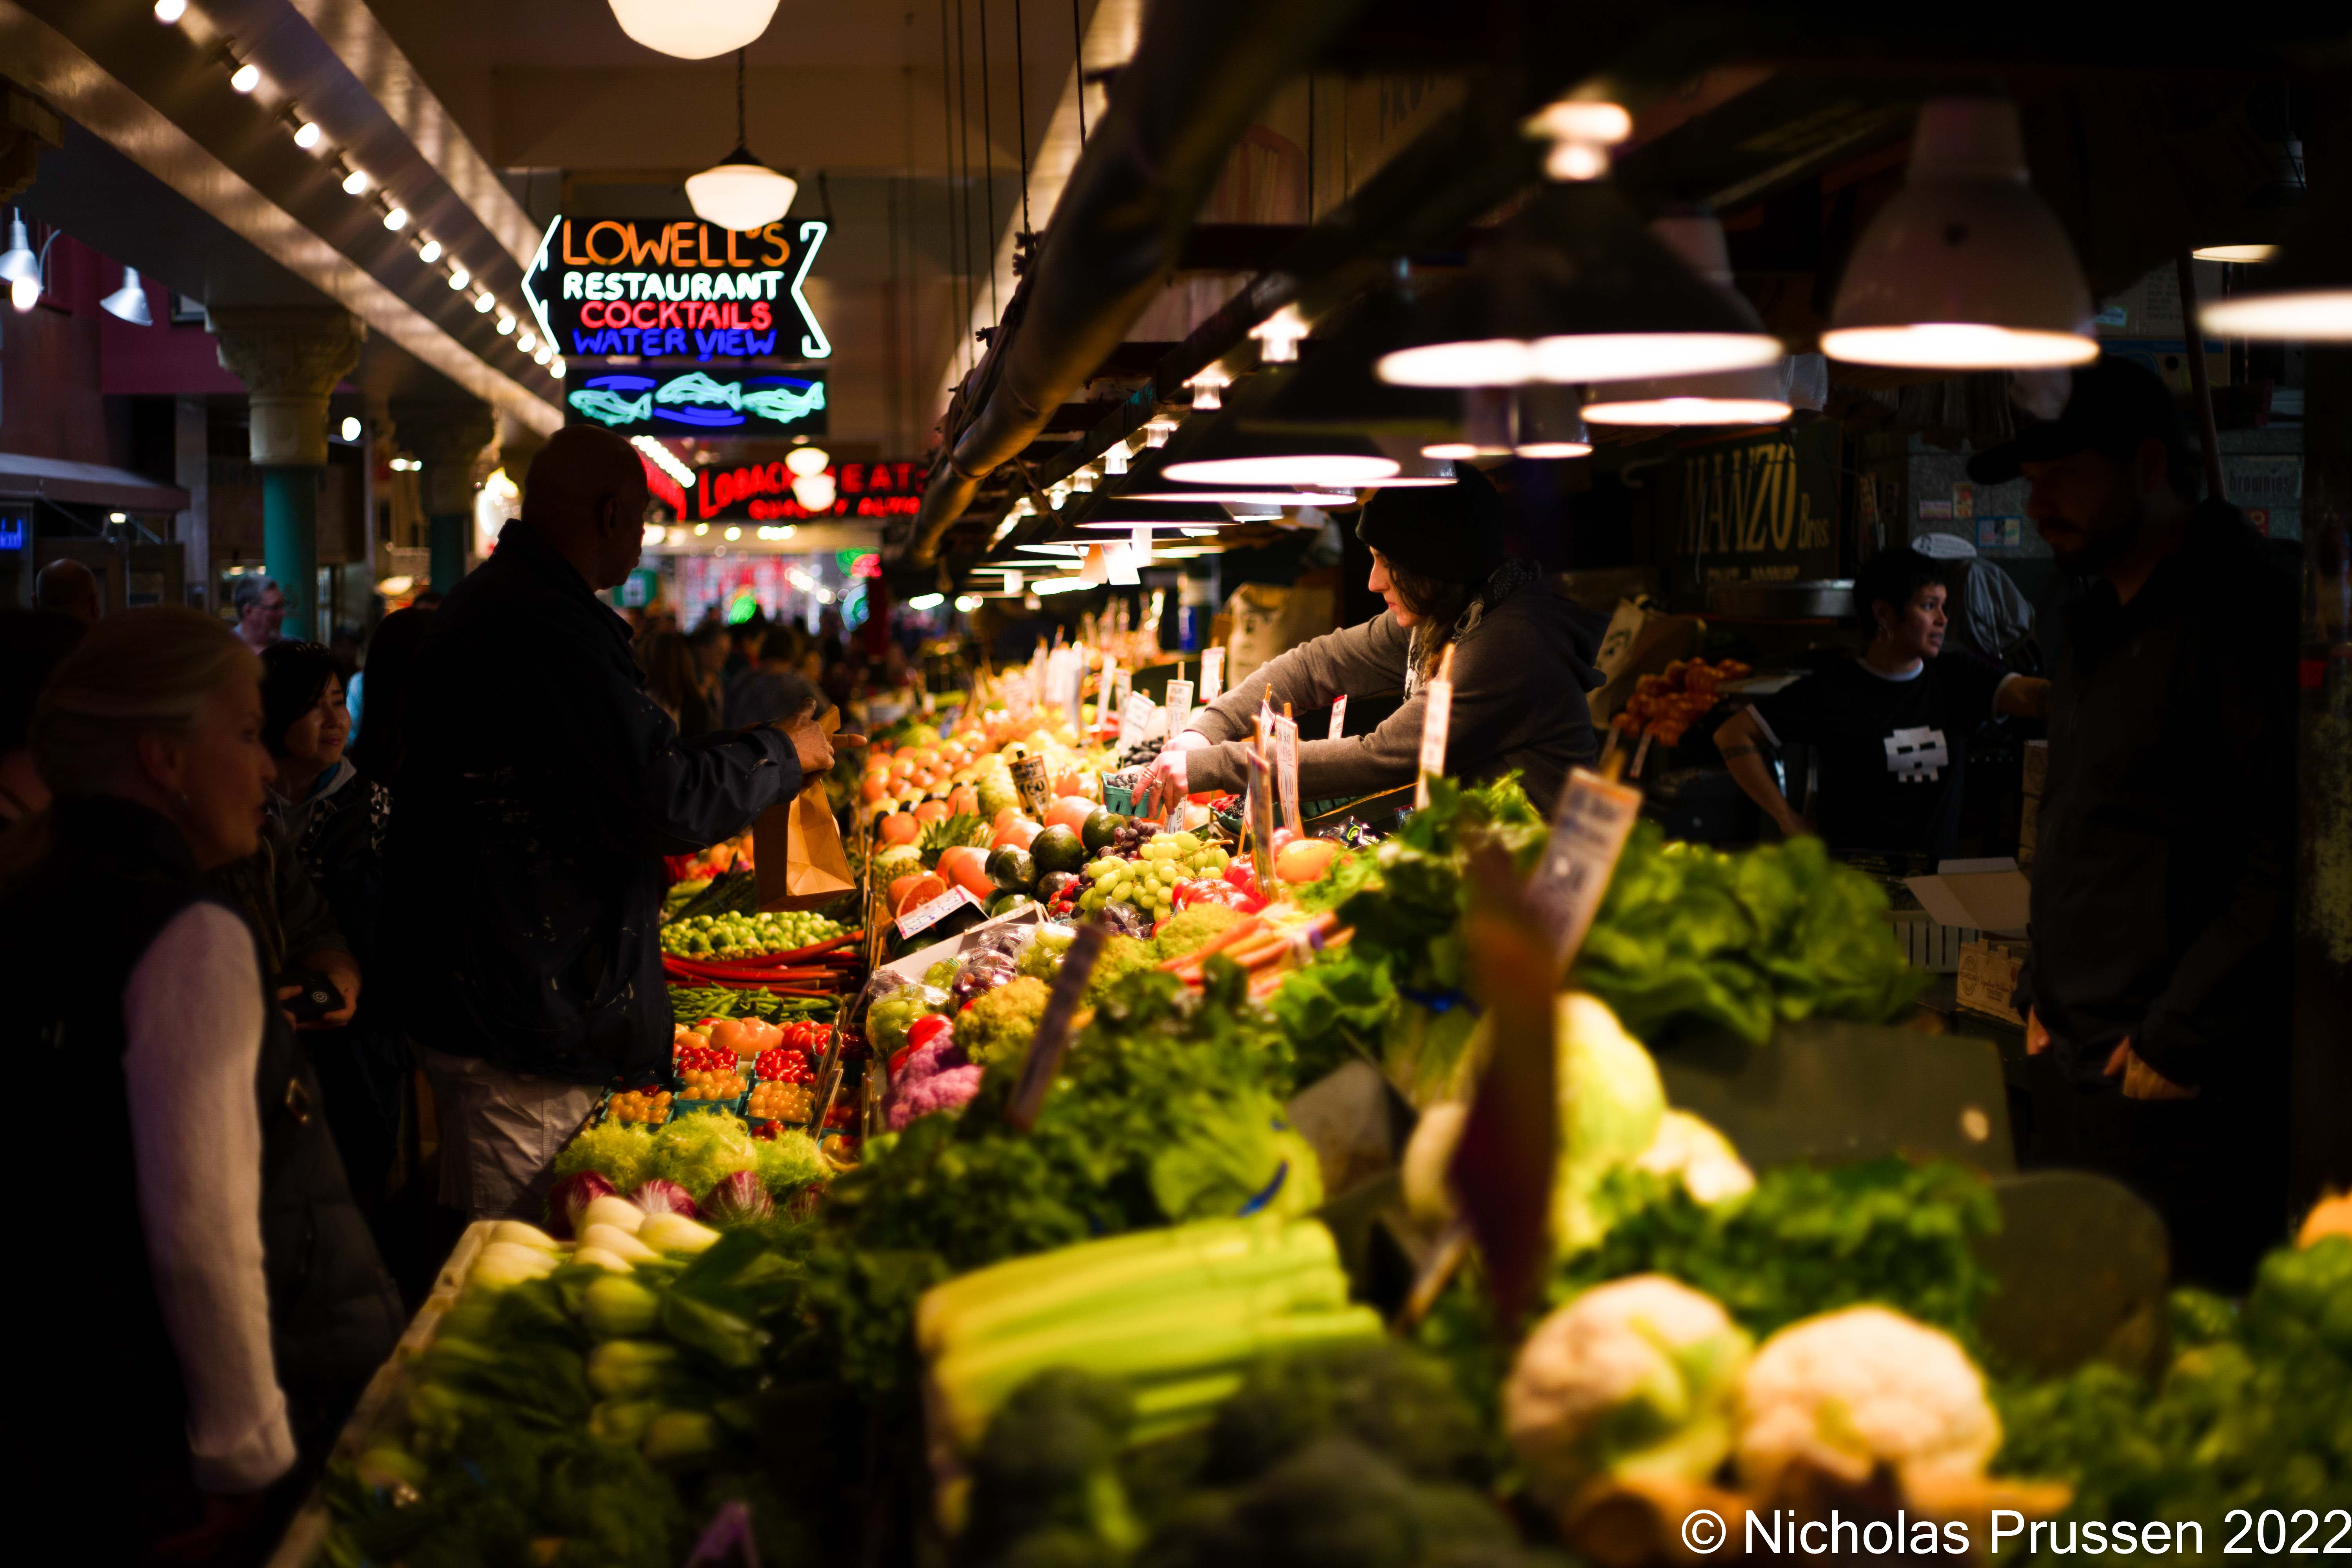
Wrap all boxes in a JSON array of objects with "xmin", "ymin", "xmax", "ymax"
[{"xmin": 522, "ymin": 219, "xmax": 833, "ymax": 362}]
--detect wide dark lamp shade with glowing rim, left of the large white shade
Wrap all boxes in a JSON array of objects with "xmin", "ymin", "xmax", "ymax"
[{"xmin": 1378, "ymin": 181, "xmax": 1780, "ymax": 388}]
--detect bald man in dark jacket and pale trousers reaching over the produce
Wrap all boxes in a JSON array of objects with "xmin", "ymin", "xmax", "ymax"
[{"xmin": 383, "ymin": 425, "xmax": 861, "ymax": 1218}]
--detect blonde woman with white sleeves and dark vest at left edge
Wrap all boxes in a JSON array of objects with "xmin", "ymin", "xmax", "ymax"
[{"xmin": 0, "ymin": 609, "xmax": 400, "ymax": 1561}]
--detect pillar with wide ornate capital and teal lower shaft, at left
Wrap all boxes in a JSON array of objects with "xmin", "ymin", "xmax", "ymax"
[{"xmin": 212, "ymin": 308, "xmax": 367, "ymax": 637}]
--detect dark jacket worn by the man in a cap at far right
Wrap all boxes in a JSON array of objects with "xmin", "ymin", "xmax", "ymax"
[{"xmin": 2020, "ymin": 501, "xmax": 2298, "ymax": 1086}]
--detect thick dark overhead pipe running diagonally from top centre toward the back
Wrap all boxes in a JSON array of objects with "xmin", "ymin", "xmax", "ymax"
[{"xmin": 906, "ymin": 0, "xmax": 1362, "ymax": 564}]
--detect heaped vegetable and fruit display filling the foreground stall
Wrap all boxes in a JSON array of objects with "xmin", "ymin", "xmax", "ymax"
[{"xmin": 303, "ymin": 733, "xmax": 2352, "ymax": 1568}]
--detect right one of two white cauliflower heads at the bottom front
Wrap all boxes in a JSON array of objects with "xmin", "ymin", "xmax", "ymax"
[{"xmin": 1738, "ymin": 1307, "xmax": 2002, "ymax": 1493}]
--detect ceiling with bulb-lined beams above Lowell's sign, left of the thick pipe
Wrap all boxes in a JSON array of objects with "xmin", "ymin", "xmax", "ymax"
[{"xmin": 0, "ymin": 0, "xmax": 1096, "ymax": 454}]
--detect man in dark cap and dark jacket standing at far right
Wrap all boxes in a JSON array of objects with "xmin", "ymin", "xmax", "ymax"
[{"xmin": 1969, "ymin": 360, "xmax": 2298, "ymax": 1290}]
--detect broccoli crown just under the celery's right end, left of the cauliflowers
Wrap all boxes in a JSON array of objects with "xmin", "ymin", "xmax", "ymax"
[{"xmin": 1202, "ymin": 1340, "xmax": 1486, "ymax": 1483}]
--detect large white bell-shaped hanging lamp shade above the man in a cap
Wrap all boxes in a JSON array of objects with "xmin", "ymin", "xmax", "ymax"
[{"xmin": 1820, "ymin": 99, "xmax": 2098, "ymax": 372}]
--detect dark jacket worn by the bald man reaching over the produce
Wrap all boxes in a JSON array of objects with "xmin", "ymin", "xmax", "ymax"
[{"xmin": 383, "ymin": 522, "xmax": 800, "ymax": 1084}]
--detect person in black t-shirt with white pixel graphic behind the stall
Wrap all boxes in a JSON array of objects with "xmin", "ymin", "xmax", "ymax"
[{"xmin": 1715, "ymin": 545, "xmax": 2049, "ymax": 858}]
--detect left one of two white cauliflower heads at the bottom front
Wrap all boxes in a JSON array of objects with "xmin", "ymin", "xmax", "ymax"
[{"xmin": 1503, "ymin": 1274, "xmax": 1750, "ymax": 1507}]
